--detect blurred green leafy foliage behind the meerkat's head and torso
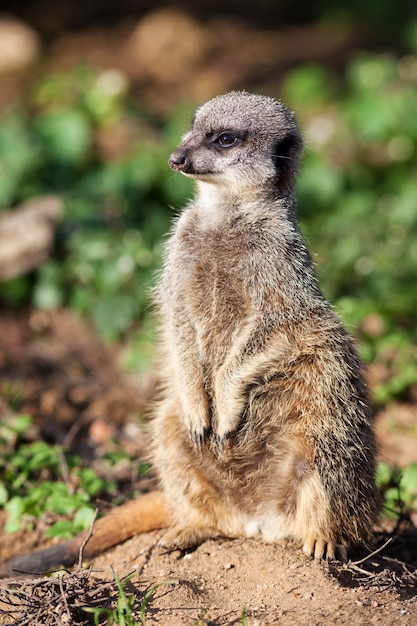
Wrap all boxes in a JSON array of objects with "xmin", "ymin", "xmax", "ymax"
[{"xmin": 0, "ymin": 48, "xmax": 417, "ymax": 402}]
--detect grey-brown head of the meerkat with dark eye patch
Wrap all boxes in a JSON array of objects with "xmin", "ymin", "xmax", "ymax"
[{"xmin": 169, "ymin": 92, "xmax": 303, "ymax": 197}]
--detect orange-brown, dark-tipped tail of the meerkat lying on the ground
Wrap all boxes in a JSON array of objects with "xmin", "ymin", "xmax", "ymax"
[{"xmin": 0, "ymin": 491, "xmax": 169, "ymax": 578}]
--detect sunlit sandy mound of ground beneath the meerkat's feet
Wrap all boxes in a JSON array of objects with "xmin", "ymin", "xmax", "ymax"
[{"xmin": 88, "ymin": 533, "xmax": 417, "ymax": 626}]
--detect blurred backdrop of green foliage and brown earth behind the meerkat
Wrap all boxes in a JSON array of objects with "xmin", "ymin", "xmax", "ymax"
[{"xmin": 0, "ymin": 0, "xmax": 417, "ymax": 540}]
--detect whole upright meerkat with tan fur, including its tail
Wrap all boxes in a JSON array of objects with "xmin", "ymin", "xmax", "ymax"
[{"xmin": 0, "ymin": 92, "xmax": 379, "ymax": 569}]
